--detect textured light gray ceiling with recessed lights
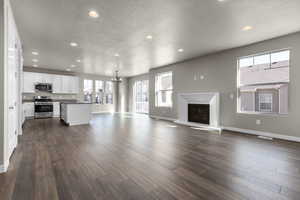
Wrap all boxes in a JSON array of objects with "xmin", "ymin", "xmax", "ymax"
[{"xmin": 11, "ymin": 0, "xmax": 300, "ymax": 76}]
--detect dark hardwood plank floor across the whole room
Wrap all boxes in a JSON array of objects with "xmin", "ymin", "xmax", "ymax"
[{"xmin": 0, "ymin": 114, "xmax": 300, "ymax": 200}]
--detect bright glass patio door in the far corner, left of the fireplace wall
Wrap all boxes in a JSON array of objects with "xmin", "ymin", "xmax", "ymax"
[{"xmin": 133, "ymin": 80, "xmax": 149, "ymax": 113}]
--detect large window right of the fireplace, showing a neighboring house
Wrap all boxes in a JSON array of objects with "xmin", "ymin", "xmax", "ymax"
[{"xmin": 238, "ymin": 50, "xmax": 290, "ymax": 114}]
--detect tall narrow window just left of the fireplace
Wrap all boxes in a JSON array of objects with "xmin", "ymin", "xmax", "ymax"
[{"xmin": 155, "ymin": 72, "xmax": 173, "ymax": 107}]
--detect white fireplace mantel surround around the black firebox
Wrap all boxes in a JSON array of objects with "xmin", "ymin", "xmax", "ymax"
[{"xmin": 175, "ymin": 92, "xmax": 221, "ymax": 130}]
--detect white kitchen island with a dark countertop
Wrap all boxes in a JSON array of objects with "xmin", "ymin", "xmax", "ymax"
[{"xmin": 60, "ymin": 102, "xmax": 92, "ymax": 126}]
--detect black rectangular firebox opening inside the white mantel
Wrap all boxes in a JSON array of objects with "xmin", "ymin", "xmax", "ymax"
[{"xmin": 188, "ymin": 104, "xmax": 210, "ymax": 125}]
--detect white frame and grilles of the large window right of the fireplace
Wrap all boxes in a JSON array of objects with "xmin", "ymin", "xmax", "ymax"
[{"xmin": 236, "ymin": 48, "xmax": 292, "ymax": 116}]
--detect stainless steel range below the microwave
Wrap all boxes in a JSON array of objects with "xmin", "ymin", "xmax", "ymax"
[{"xmin": 34, "ymin": 96, "xmax": 53, "ymax": 119}]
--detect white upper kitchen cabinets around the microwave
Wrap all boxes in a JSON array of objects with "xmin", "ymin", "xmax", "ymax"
[{"xmin": 23, "ymin": 72, "xmax": 79, "ymax": 94}]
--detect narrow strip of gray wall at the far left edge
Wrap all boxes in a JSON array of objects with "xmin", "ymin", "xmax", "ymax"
[{"xmin": 0, "ymin": 0, "xmax": 4, "ymax": 165}]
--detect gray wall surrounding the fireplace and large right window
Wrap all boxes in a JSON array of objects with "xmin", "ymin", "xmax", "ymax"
[{"xmin": 129, "ymin": 33, "xmax": 300, "ymax": 137}]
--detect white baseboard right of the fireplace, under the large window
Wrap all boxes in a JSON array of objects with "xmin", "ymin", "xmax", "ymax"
[{"xmin": 222, "ymin": 127, "xmax": 300, "ymax": 142}]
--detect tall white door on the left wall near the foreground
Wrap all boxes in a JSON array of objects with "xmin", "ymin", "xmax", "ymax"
[{"xmin": 7, "ymin": 8, "xmax": 19, "ymax": 157}]
